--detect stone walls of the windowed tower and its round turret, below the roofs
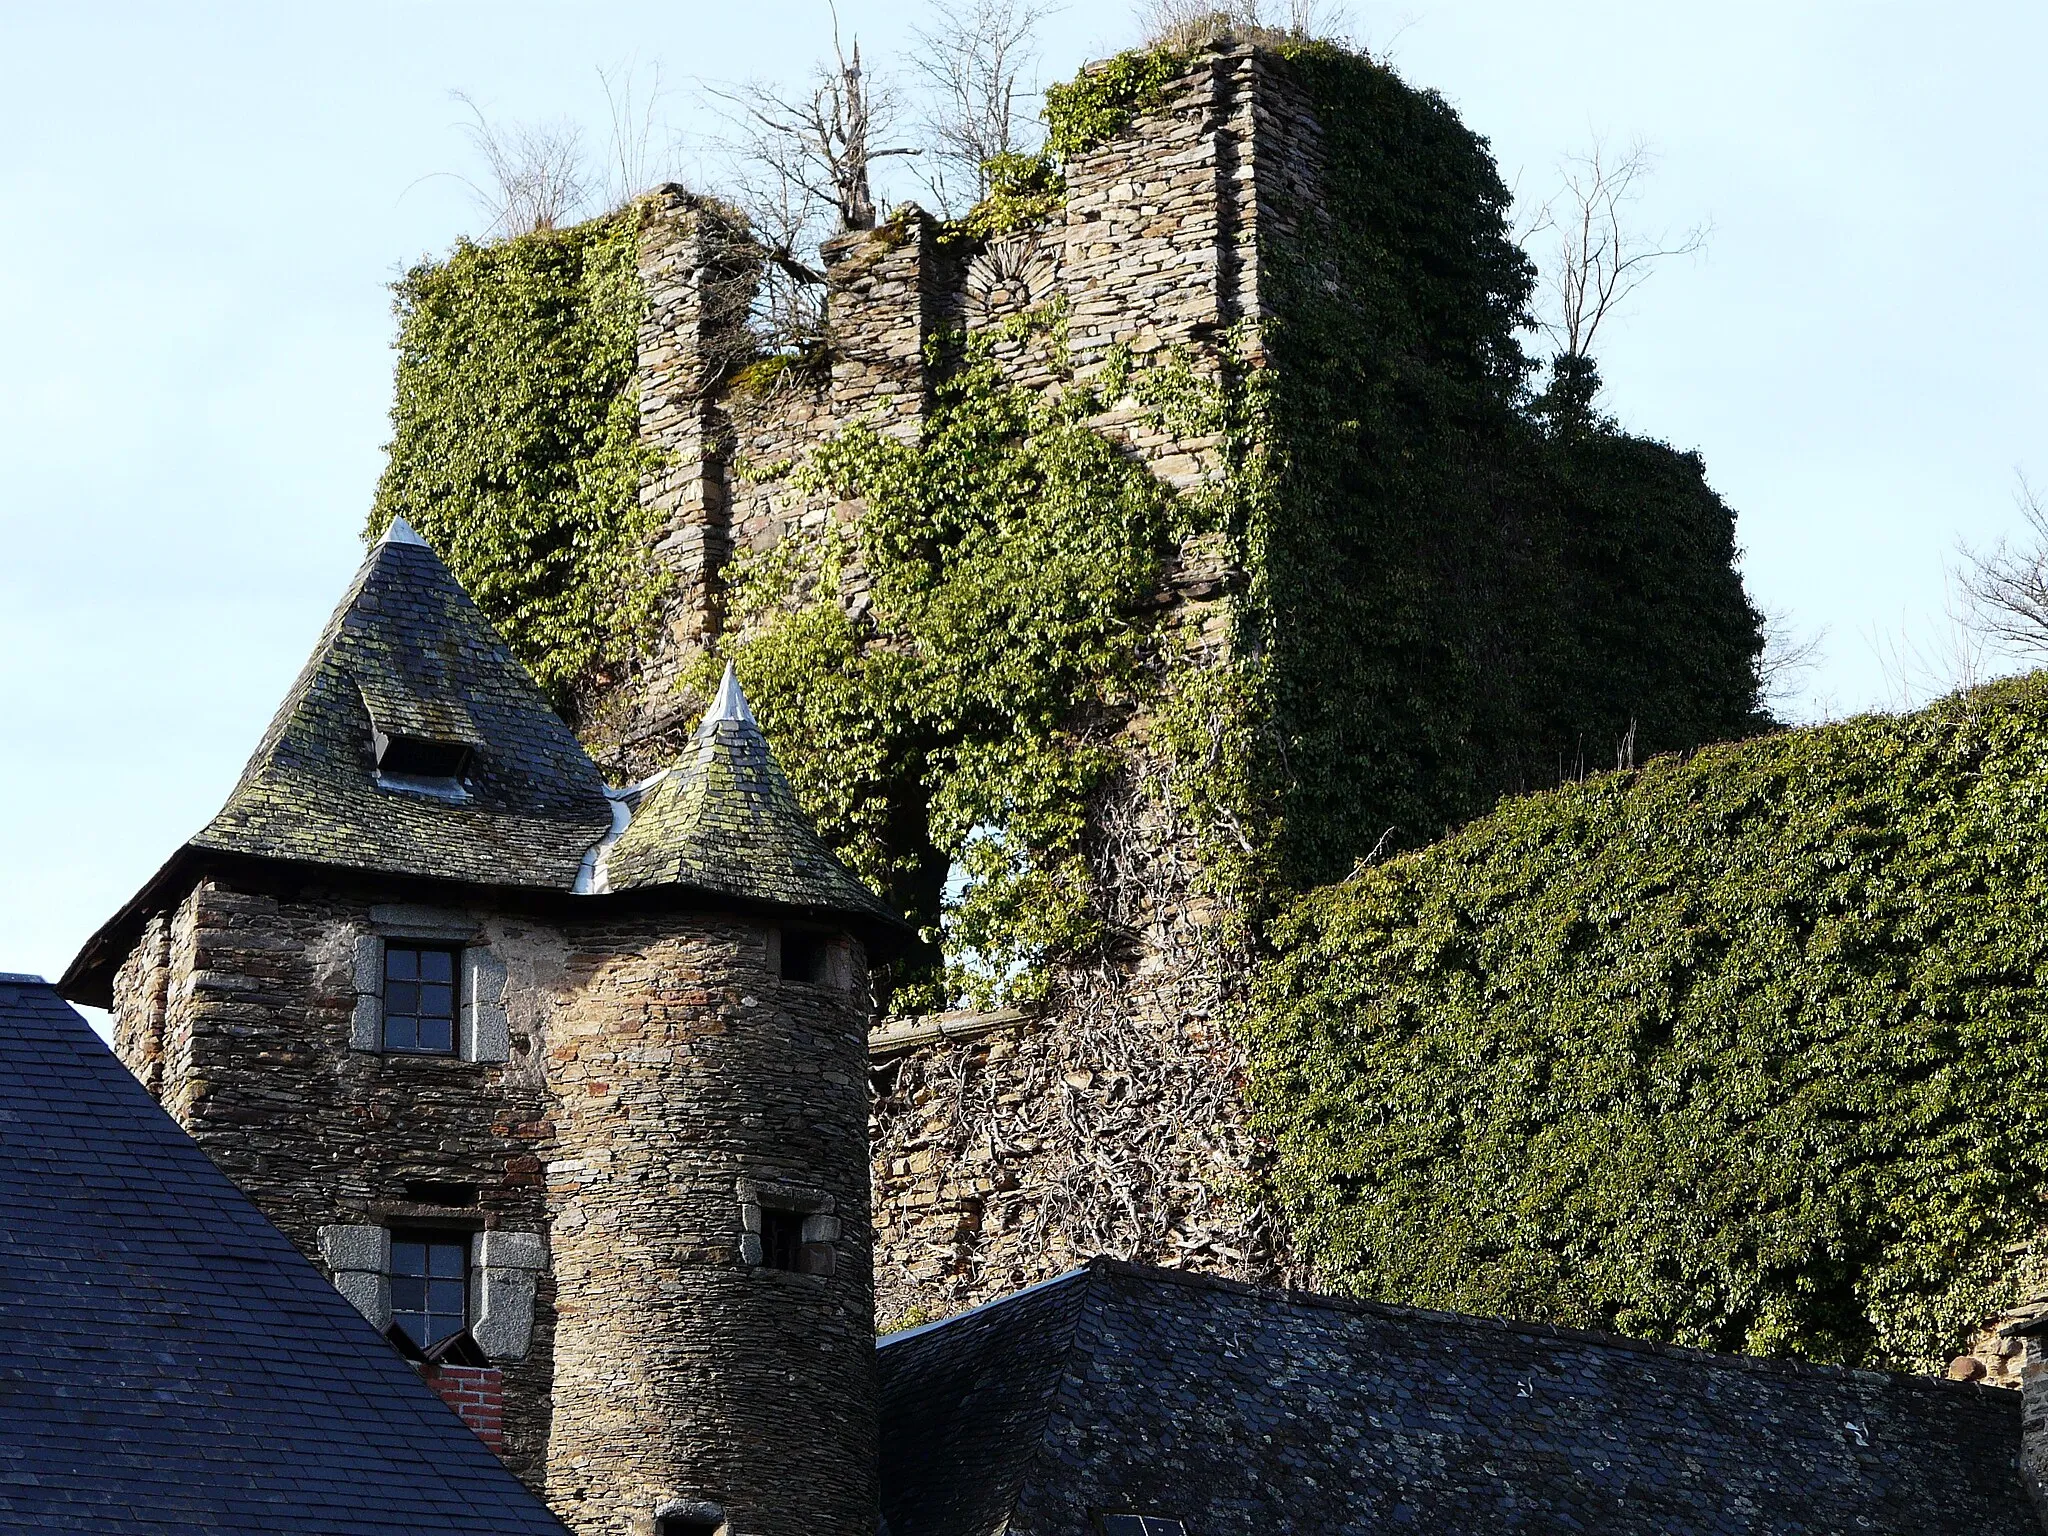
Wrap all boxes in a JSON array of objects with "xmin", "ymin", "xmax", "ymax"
[{"xmin": 115, "ymin": 870, "xmax": 874, "ymax": 1536}]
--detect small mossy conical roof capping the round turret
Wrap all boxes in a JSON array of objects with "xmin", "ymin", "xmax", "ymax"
[{"xmin": 604, "ymin": 664, "xmax": 903, "ymax": 934}]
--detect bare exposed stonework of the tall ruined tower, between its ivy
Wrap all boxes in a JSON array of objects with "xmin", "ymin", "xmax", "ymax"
[{"xmin": 596, "ymin": 45, "xmax": 1319, "ymax": 1325}]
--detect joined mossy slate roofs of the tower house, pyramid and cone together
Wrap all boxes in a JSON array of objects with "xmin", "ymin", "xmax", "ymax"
[{"xmin": 61, "ymin": 518, "xmax": 913, "ymax": 1008}]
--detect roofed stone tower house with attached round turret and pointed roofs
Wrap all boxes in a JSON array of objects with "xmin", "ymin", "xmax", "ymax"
[{"xmin": 63, "ymin": 522, "xmax": 905, "ymax": 1536}]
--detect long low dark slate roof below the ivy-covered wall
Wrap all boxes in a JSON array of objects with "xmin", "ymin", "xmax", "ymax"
[{"xmin": 879, "ymin": 1260, "xmax": 2040, "ymax": 1536}]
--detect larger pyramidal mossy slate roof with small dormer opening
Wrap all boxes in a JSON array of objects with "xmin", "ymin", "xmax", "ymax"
[{"xmin": 193, "ymin": 524, "xmax": 612, "ymax": 891}]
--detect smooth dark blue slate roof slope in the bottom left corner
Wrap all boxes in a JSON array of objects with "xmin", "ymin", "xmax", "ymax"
[{"xmin": 0, "ymin": 975, "xmax": 563, "ymax": 1536}]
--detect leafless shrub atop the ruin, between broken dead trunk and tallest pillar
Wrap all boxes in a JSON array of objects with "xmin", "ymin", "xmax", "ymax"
[{"xmin": 915, "ymin": 0, "xmax": 1053, "ymax": 213}]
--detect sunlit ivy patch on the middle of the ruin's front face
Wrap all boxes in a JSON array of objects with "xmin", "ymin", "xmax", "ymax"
[{"xmin": 707, "ymin": 335, "xmax": 1182, "ymax": 1010}]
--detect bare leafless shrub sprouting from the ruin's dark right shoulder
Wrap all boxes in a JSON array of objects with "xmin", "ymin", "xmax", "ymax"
[{"xmin": 1524, "ymin": 139, "xmax": 1712, "ymax": 358}]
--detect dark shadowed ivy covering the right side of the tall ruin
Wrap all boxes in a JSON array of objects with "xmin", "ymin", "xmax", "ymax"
[{"xmin": 1243, "ymin": 43, "xmax": 1765, "ymax": 889}]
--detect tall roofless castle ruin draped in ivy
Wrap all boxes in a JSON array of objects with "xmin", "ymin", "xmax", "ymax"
[{"xmin": 373, "ymin": 35, "xmax": 1767, "ymax": 1323}]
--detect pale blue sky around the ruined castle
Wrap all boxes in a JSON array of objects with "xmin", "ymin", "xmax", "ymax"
[{"xmin": 0, "ymin": 0, "xmax": 2048, "ymax": 975}]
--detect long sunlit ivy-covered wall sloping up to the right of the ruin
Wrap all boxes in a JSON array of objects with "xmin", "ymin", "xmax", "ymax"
[{"xmin": 1251, "ymin": 674, "xmax": 2048, "ymax": 1368}]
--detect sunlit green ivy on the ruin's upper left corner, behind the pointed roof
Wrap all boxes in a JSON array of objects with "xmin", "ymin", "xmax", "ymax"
[{"xmin": 369, "ymin": 209, "xmax": 662, "ymax": 711}]
